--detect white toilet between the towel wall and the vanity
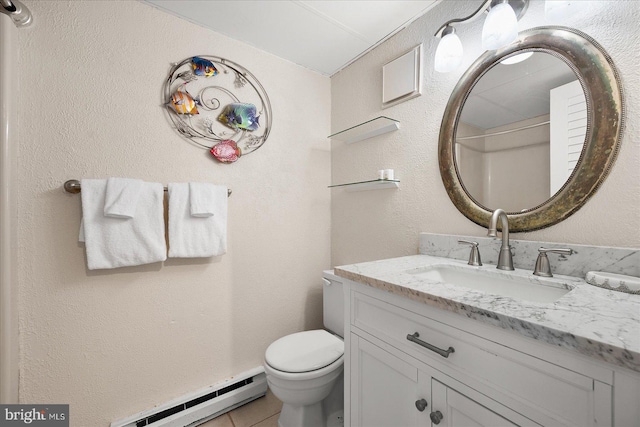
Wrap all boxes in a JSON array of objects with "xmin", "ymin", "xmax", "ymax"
[{"xmin": 264, "ymin": 271, "xmax": 344, "ymax": 427}]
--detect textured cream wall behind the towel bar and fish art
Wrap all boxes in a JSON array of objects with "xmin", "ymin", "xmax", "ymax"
[{"xmin": 15, "ymin": 1, "xmax": 330, "ymax": 426}]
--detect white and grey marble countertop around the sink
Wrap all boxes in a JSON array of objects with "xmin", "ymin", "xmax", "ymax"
[{"xmin": 334, "ymin": 255, "xmax": 640, "ymax": 372}]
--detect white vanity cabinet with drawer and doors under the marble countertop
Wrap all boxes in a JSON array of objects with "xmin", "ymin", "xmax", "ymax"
[{"xmin": 343, "ymin": 279, "xmax": 640, "ymax": 427}]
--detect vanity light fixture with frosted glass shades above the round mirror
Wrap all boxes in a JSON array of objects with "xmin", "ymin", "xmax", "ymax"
[{"xmin": 434, "ymin": 0, "xmax": 529, "ymax": 73}]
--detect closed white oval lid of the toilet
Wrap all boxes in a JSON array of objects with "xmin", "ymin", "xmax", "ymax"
[{"xmin": 264, "ymin": 330, "xmax": 344, "ymax": 372}]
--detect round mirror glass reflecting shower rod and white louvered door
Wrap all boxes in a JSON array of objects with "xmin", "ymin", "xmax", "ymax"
[{"xmin": 454, "ymin": 52, "xmax": 587, "ymax": 213}]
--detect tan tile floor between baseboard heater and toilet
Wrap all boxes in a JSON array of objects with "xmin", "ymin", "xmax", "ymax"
[{"xmin": 199, "ymin": 390, "xmax": 282, "ymax": 427}]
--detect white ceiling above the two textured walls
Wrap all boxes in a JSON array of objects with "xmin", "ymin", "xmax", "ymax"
[{"xmin": 143, "ymin": 0, "xmax": 442, "ymax": 76}]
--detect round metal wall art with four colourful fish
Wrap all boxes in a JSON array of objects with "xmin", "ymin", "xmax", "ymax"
[{"xmin": 161, "ymin": 55, "xmax": 272, "ymax": 160}]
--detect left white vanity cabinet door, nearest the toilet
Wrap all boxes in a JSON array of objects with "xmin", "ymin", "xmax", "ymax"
[{"xmin": 351, "ymin": 333, "xmax": 431, "ymax": 427}]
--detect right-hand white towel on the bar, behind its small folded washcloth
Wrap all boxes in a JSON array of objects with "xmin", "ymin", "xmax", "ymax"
[{"xmin": 169, "ymin": 183, "xmax": 227, "ymax": 258}]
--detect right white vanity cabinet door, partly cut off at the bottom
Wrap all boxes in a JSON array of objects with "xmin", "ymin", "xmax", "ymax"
[{"xmin": 430, "ymin": 380, "xmax": 537, "ymax": 427}]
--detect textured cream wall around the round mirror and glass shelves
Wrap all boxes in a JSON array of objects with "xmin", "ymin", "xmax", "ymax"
[{"xmin": 331, "ymin": 0, "xmax": 640, "ymax": 265}]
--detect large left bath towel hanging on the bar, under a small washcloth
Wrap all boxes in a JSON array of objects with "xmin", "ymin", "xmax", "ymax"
[{"xmin": 81, "ymin": 179, "xmax": 167, "ymax": 270}]
